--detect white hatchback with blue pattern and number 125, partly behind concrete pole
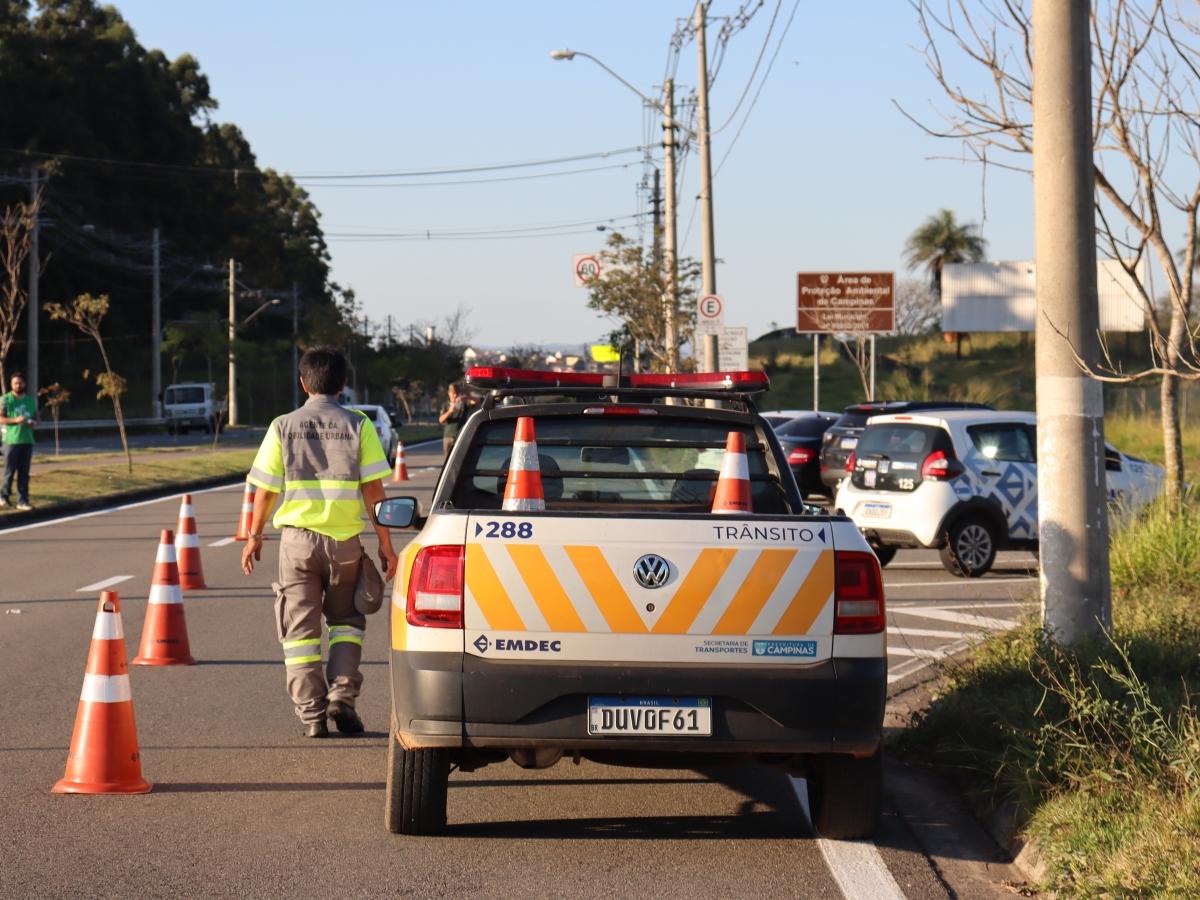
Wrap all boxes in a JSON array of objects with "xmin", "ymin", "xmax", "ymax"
[{"xmin": 835, "ymin": 409, "xmax": 1163, "ymax": 577}]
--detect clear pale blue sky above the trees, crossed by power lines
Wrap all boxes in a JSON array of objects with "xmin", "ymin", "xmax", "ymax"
[{"xmin": 110, "ymin": 0, "xmax": 1033, "ymax": 346}]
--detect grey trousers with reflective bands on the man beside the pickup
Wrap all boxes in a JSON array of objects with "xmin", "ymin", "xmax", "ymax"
[{"xmin": 272, "ymin": 528, "xmax": 367, "ymax": 725}]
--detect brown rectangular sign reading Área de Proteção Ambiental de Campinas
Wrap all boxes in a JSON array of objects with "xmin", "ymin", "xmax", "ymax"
[{"xmin": 796, "ymin": 272, "xmax": 895, "ymax": 335}]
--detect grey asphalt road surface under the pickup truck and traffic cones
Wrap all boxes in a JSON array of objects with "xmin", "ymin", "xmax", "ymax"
[{"xmin": 0, "ymin": 444, "xmax": 1031, "ymax": 900}]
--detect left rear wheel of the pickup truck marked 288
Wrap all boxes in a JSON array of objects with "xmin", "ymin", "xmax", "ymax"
[{"xmin": 383, "ymin": 718, "xmax": 450, "ymax": 834}]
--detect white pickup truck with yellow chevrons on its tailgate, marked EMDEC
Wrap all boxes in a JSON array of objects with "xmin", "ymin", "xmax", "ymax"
[{"xmin": 374, "ymin": 368, "xmax": 887, "ymax": 838}]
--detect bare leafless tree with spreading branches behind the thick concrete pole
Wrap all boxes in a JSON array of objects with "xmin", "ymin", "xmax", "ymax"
[{"xmin": 910, "ymin": 0, "xmax": 1200, "ymax": 506}]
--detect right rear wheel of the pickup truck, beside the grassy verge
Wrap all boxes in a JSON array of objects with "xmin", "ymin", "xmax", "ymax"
[{"xmin": 809, "ymin": 748, "xmax": 883, "ymax": 840}]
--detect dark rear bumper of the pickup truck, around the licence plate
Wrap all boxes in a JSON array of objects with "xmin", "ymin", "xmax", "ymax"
[{"xmin": 391, "ymin": 650, "xmax": 887, "ymax": 755}]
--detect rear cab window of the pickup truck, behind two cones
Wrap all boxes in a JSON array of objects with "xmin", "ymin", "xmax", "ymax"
[{"xmin": 454, "ymin": 416, "xmax": 791, "ymax": 515}]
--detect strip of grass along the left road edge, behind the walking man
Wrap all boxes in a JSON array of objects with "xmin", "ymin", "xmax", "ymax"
[{"xmin": 0, "ymin": 448, "xmax": 257, "ymax": 515}]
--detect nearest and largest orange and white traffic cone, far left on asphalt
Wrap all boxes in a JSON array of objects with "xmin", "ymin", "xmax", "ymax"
[{"xmin": 50, "ymin": 590, "xmax": 151, "ymax": 793}]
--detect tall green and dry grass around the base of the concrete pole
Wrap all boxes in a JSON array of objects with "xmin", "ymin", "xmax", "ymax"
[{"xmin": 899, "ymin": 496, "xmax": 1200, "ymax": 899}]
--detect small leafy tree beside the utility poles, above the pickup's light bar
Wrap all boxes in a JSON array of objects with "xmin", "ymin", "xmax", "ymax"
[{"xmin": 588, "ymin": 232, "xmax": 700, "ymax": 372}]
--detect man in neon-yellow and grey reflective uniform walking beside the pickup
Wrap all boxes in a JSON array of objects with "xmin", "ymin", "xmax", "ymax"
[{"xmin": 241, "ymin": 347, "xmax": 396, "ymax": 738}]
